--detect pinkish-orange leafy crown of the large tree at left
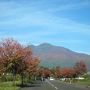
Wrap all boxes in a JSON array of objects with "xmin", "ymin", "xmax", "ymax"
[{"xmin": 0, "ymin": 39, "xmax": 40, "ymax": 84}]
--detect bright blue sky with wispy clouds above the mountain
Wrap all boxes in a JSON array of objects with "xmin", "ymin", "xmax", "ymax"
[{"xmin": 0, "ymin": 0, "xmax": 90, "ymax": 54}]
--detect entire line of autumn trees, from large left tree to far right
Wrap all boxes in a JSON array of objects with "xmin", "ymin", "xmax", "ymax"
[{"xmin": 0, "ymin": 39, "xmax": 87, "ymax": 85}]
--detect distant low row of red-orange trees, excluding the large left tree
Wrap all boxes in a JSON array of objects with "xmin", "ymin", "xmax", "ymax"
[{"xmin": 39, "ymin": 61, "xmax": 87, "ymax": 78}]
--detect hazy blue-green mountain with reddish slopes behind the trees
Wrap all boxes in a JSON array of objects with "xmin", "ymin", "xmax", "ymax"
[{"xmin": 29, "ymin": 43, "xmax": 90, "ymax": 70}]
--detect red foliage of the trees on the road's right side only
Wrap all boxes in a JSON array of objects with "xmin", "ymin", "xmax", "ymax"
[{"xmin": 54, "ymin": 61, "xmax": 87, "ymax": 78}]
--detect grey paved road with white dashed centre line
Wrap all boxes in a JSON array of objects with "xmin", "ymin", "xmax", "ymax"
[{"xmin": 21, "ymin": 80, "xmax": 90, "ymax": 90}]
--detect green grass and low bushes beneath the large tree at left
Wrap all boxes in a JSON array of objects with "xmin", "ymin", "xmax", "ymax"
[{"xmin": 0, "ymin": 74, "xmax": 35, "ymax": 90}]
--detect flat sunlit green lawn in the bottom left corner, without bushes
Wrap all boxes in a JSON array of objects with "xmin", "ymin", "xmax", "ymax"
[{"xmin": 0, "ymin": 82, "xmax": 20, "ymax": 90}]
